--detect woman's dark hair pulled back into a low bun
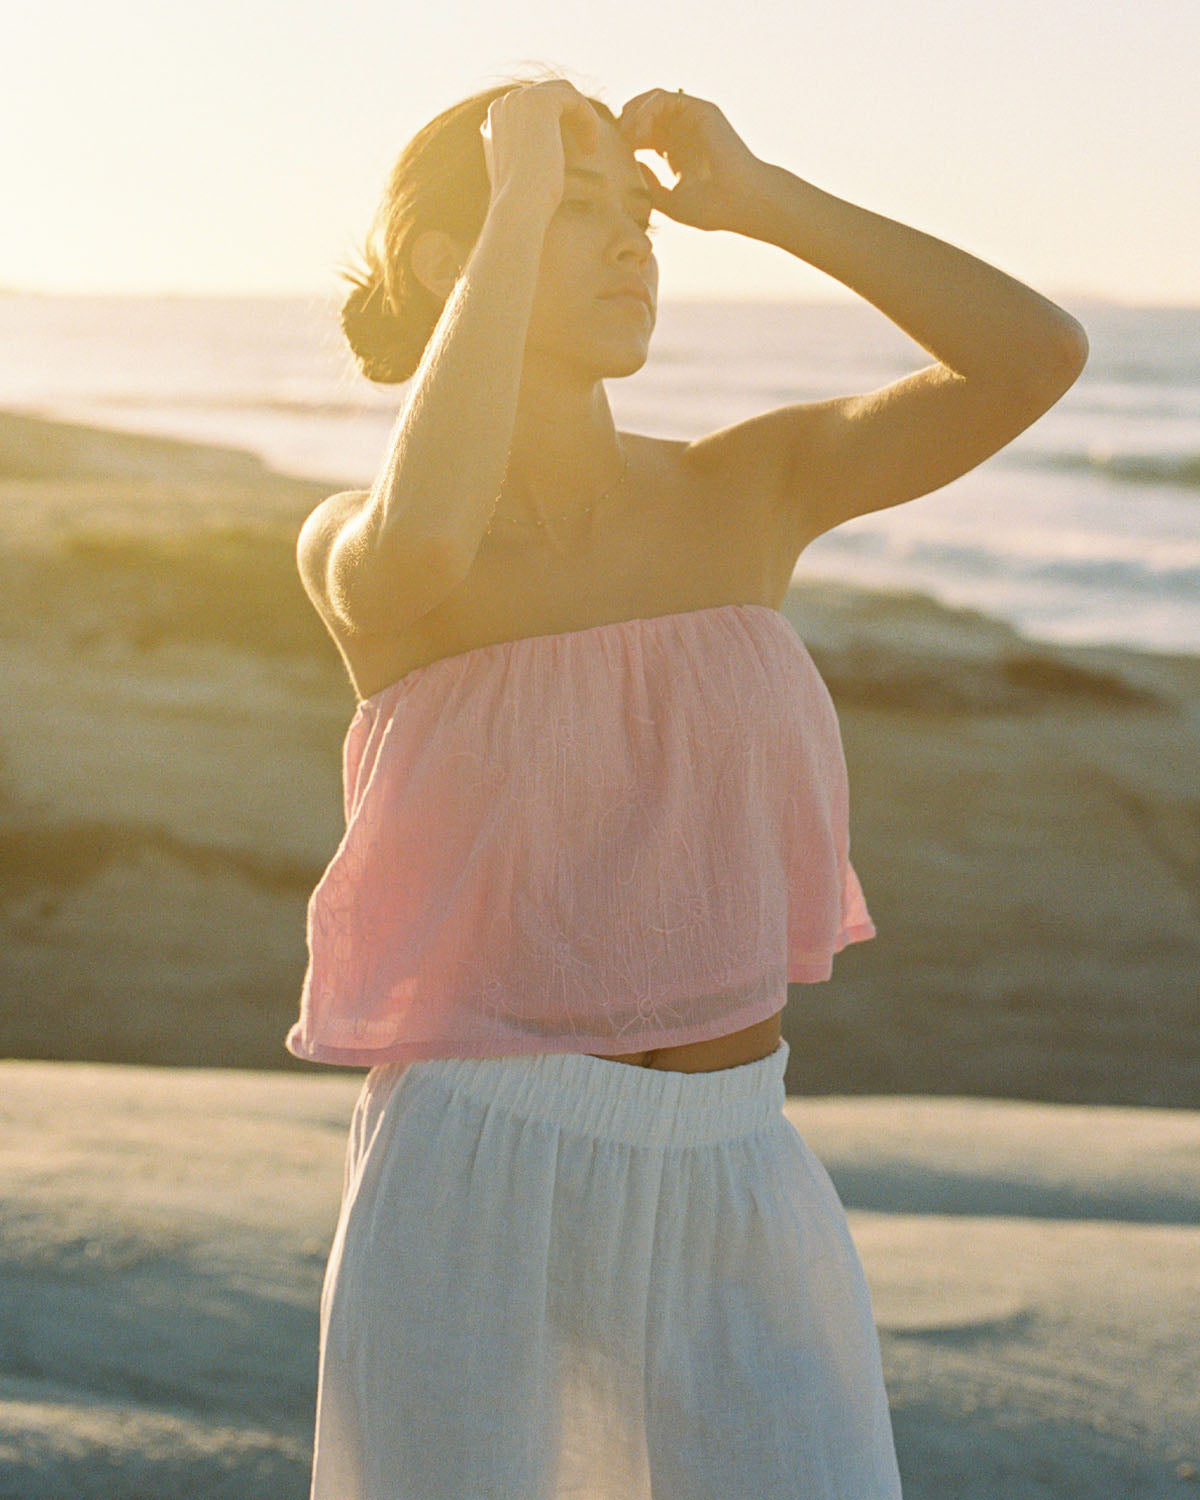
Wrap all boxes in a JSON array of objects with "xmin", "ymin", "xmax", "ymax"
[{"xmin": 339, "ymin": 72, "xmax": 617, "ymax": 386}]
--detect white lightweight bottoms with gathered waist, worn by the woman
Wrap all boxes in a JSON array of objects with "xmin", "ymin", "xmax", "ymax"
[{"xmin": 311, "ymin": 1043, "xmax": 900, "ymax": 1500}]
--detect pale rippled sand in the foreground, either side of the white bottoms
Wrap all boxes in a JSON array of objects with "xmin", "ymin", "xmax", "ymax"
[{"xmin": 0, "ymin": 1061, "xmax": 1200, "ymax": 1500}]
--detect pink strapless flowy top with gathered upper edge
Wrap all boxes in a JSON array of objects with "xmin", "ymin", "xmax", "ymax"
[{"xmin": 285, "ymin": 605, "xmax": 875, "ymax": 1067}]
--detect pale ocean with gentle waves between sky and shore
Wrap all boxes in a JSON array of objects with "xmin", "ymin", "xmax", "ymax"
[{"xmin": 0, "ymin": 291, "xmax": 1200, "ymax": 654}]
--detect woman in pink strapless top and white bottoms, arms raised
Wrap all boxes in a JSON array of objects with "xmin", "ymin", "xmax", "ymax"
[{"xmin": 287, "ymin": 67, "xmax": 1086, "ymax": 1500}]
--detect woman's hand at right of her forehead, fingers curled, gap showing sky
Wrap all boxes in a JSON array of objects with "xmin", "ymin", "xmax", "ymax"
[{"xmin": 617, "ymin": 89, "xmax": 771, "ymax": 234}]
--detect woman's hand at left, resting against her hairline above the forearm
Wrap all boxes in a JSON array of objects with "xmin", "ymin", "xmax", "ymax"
[{"xmin": 480, "ymin": 78, "xmax": 600, "ymax": 219}]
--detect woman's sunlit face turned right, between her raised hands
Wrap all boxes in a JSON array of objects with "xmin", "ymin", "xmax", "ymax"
[{"xmin": 527, "ymin": 120, "xmax": 659, "ymax": 380}]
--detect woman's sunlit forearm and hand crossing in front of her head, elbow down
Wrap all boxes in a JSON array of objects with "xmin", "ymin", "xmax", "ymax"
[{"xmin": 312, "ymin": 80, "xmax": 600, "ymax": 633}]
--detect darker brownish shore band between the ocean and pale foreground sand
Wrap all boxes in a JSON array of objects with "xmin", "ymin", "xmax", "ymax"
[{"xmin": 0, "ymin": 413, "xmax": 1200, "ymax": 1107}]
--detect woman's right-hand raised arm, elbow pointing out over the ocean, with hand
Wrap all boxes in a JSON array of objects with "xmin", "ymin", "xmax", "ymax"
[{"xmin": 621, "ymin": 89, "xmax": 1088, "ymax": 555}]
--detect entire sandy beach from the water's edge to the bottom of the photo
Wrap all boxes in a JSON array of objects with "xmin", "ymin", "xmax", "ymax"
[{"xmin": 0, "ymin": 414, "xmax": 1200, "ymax": 1500}]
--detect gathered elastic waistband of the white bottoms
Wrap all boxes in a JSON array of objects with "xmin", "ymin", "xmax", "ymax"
[{"xmin": 390, "ymin": 1040, "xmax": 788, "ymax": 1146}]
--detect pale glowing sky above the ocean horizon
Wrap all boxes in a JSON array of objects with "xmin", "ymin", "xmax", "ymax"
[{"xmin": 0, "ymin": 0, "xmax": 1200, "ymax": 311}]
